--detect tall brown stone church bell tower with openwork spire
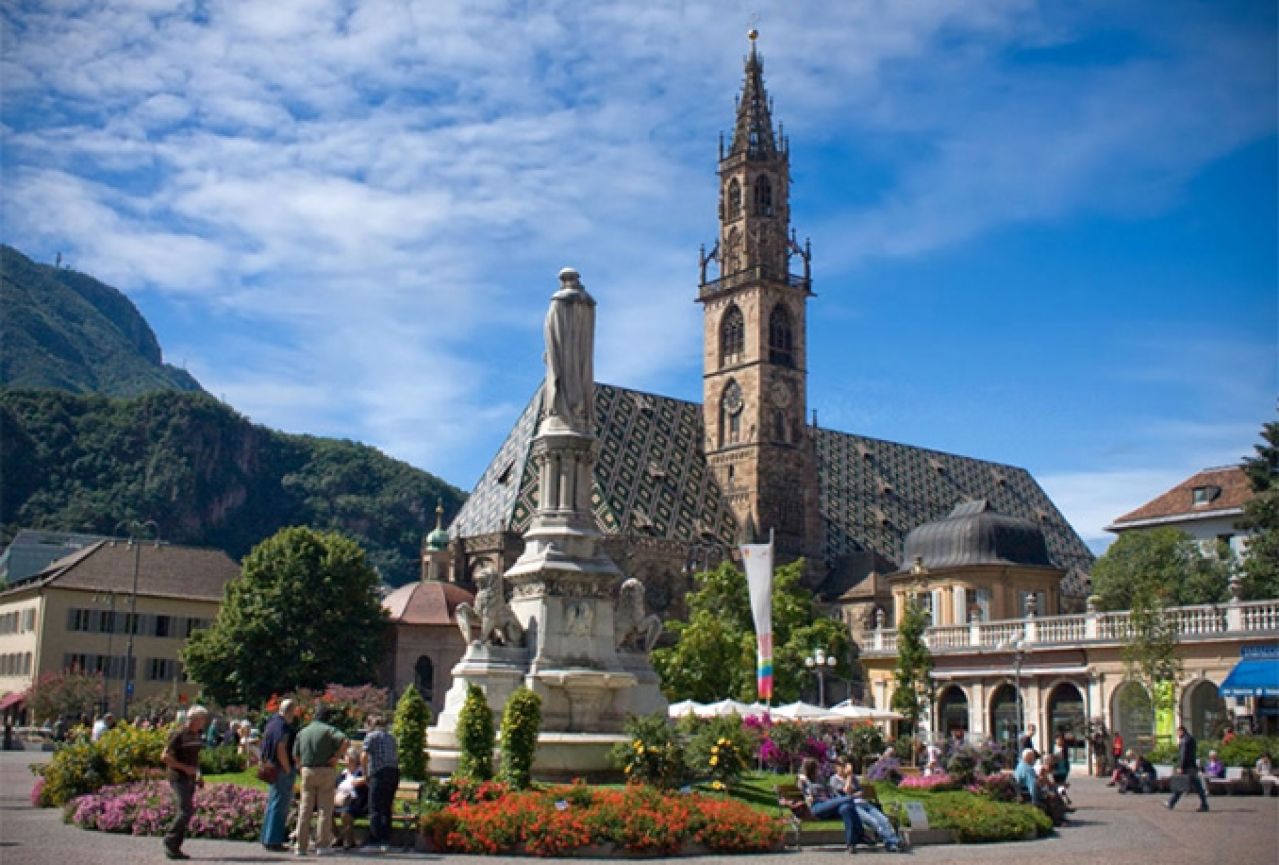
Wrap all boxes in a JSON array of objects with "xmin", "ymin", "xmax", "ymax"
[{"xmin": 697, "ymin": 31, "xmax": 820, "ymax": 560}]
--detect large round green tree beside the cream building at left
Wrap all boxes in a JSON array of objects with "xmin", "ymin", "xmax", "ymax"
[{"xmin": 182, "ymin": 527, "xmax": 386, "ymax": 705}]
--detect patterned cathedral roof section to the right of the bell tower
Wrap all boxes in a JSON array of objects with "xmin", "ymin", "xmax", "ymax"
[{"xmin": 813, "ymin": 429, "xmax": 1094, "ymax": 596}]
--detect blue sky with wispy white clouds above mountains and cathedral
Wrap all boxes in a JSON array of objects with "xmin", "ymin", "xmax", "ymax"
[{"xmin": 0, "ymin": 0, "xmax": 1279, "ymax": 550}]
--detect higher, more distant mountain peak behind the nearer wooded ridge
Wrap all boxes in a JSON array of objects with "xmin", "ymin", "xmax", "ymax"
[{"xmin": 0, "ymin": 246, "xmax": 201, "ymax": 397}]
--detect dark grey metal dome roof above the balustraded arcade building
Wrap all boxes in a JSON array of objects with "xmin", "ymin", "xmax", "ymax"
[{"xmin": 902, "ymin": 499, "xmax": 1055, "ymax": 571}]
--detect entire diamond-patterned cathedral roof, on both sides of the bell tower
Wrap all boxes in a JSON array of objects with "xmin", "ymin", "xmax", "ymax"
[{"xmin": 449, "ymin": 384, "xmax": 1092, "ymax": 596}]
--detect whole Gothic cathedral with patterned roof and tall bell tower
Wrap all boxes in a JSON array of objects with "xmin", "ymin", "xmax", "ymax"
[{"xmin": 449, "ymin": 32, "xmax": 1092, "ymax": 635}]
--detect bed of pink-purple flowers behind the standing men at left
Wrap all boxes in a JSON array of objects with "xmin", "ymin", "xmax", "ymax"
[{"xmin": 65, "ymin": 781, "xmax": 266, "ymax": 841}]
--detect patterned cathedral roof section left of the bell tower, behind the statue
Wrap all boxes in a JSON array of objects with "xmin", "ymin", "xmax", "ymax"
[{"xmin": 449, "ymin": 384, "xmax": 737, "ymax": 544}]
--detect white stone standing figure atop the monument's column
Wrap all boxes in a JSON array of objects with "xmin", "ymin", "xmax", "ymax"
[{"xmin": 544, "ymin": 267, "xmax": 595, "ymax": 434}]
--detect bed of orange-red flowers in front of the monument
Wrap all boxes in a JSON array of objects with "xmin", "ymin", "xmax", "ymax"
[{"xmin": 421, "ymin": 784, "xmax": 781, "ymax": 856}]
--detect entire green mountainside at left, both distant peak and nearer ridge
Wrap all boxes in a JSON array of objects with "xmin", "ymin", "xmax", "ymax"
[{"xmin": 0, "ymin": 247, "xmax": 464, "ymax": 585}]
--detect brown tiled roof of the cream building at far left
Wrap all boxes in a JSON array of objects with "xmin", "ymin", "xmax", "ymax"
[{"xmin": 0, "ymin": 540, "xmax": 239, "ymax": 601}]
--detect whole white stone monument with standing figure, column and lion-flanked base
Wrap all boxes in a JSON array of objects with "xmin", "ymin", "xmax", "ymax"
[{"xmin": 427, "ymin": 267, "xmax": 666, "ymax": 777}]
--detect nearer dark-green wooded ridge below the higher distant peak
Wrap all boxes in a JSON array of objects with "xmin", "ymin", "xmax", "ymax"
[{"xmin": 0, "ymin": 389, "xmax": 464, "ymax": 585}]
